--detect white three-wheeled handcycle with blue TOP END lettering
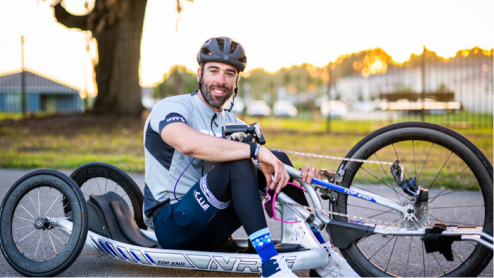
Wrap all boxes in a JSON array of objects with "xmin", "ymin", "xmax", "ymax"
[{"xmin": 0, "ymin": 122, "xmax": 494, "ymax": 277}]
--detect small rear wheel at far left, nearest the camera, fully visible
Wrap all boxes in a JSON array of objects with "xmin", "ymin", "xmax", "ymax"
[{"xmin": 0, "ymin": 170, "xmax": 88, "ymax": 277}]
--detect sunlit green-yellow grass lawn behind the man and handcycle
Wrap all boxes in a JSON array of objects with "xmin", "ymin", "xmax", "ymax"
[{"xmin": 0, "ymin": 115, "xmax": 494, "ymax": 173}]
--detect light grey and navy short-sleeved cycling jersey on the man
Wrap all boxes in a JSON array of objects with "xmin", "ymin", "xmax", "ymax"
[{"xmin": 143, "ymin": 91, "xmax": 245, "ymax": 222}]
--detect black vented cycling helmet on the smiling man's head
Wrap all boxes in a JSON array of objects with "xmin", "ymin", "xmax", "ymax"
[{"xmin": 197, "ymin": 37, "xmax": 247, "ymax": 72}]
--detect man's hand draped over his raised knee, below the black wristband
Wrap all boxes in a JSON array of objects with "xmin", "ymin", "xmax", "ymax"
[{"xmin": 257, "ymin": 147, "xmax": 290, "ymax": 194}]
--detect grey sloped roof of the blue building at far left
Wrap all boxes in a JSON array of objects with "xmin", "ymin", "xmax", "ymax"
[{"xmin": 0, "ymin": 71, "xmax": 79, "ymax": 94}]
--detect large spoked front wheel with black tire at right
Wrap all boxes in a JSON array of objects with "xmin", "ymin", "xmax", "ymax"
[{"xmin": 328, "ymin": 122, "xmax": 494, "ymax": 277}]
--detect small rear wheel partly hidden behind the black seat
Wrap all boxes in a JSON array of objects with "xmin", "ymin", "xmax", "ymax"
[{"xmin": 70, "ymin": 162, "xmax": 147, "ymax": 229}]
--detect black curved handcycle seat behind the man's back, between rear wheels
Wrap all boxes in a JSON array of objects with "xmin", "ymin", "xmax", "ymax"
[{"xmin": 87, "ymin": 192, "xmax": 158, "ymax": 248}]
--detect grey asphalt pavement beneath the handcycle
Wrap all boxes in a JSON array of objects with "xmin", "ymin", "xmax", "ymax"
[{"xmin": 0, "ymin": 169, "xmax": 494, "ymax": 277}]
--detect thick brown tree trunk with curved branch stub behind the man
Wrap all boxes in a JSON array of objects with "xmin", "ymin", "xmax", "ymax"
[{"xmin": 54, "ymin": 0, "xmax": 146, "ymax": 116}]
